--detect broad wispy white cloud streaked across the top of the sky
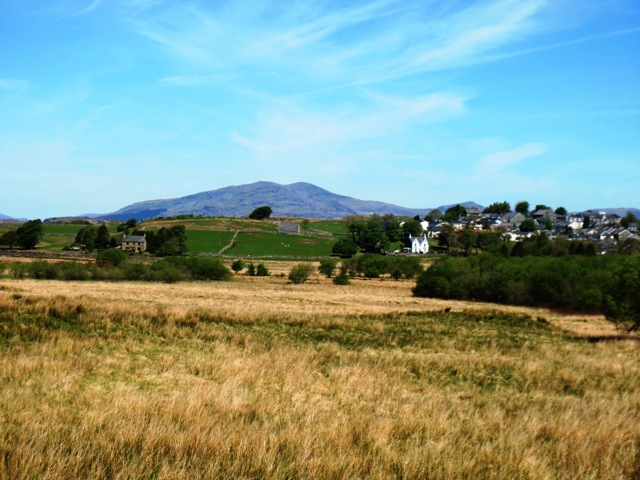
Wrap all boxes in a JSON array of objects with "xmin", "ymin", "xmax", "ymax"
[{"xmin": 130, "ymin": 0, "xmax": 545, "ymax": 84}]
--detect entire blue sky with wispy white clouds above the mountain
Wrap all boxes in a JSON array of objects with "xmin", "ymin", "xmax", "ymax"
[{"xmin": 0, "ymin": 0, "xmax": 640, "ymax": 218}]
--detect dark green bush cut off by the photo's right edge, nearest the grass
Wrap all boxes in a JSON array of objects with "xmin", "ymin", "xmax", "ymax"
[{"xmin": 606, "ymin": 255, "xmax": 640, "ymax": 330}]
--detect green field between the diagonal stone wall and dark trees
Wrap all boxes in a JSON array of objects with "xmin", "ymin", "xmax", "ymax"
[{"xmin": 227, "ymin": 233, "xmax": 335, "ymax": 257}]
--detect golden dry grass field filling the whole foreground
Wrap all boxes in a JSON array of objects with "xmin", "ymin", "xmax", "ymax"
[{"xmin": 0, "ymin": 262, "xmax": 640, "ymax": 479}]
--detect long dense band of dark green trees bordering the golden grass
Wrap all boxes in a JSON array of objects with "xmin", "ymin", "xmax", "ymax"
[{"xmin": 413, "ymin": 254, "xmax": 640, "ymax": 329}]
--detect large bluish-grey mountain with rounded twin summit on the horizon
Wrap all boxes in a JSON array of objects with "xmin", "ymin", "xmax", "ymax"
[{"xmin": 104, "ymin": 182, "xmax": 444, "ymax": 220}]
